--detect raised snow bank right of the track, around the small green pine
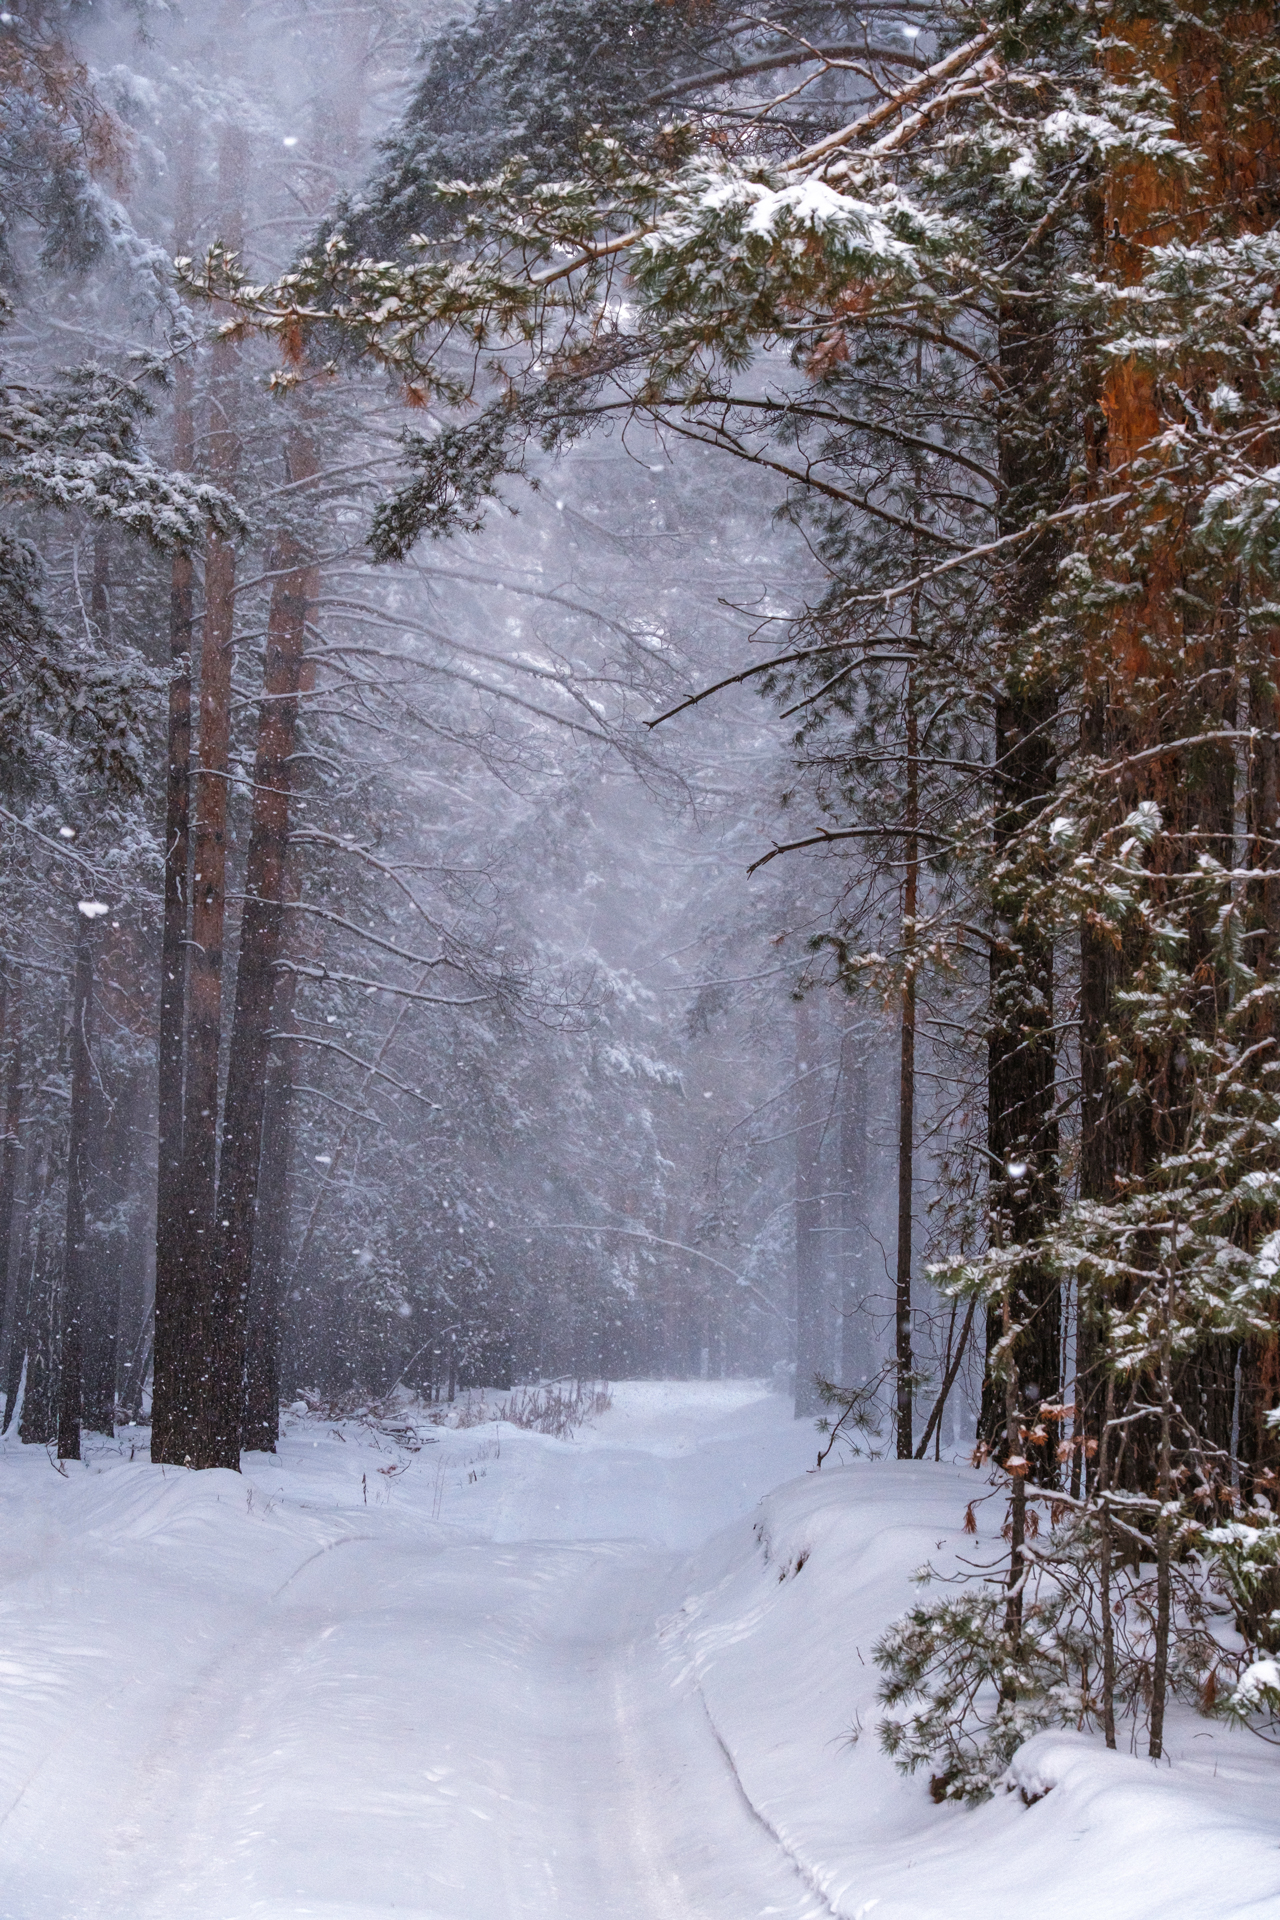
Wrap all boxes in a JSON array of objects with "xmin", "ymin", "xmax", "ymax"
[{"xmin": 662, "ymin": 1461, "xmax": 1280, "ymax": 1920}]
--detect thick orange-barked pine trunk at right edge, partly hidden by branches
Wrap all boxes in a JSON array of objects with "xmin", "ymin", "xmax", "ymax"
[{"xmin": 1086, "ymin": 8, "xmax": 1280, "ymax": 1512}]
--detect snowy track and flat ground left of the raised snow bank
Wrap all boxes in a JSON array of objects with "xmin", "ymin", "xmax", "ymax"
[{"xmin": 0, "ymin": 1386, "xmax": 825, "ymax": 1920}]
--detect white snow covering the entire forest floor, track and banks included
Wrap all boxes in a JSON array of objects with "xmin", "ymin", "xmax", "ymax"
[{"xmin": 0, "ymin": 1382, "xmax": 1280, "ymax": 1920}]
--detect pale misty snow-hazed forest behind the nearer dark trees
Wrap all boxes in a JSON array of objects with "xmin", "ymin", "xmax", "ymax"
[{"xmin": 0, "ymin": 0, "xmax": 981, "ymax": 1444}]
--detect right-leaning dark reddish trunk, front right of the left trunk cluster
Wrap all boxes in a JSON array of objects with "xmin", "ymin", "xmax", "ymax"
[{"xmin": 209, "ymin": 432, "xmax": 319, "ymax": 1467}]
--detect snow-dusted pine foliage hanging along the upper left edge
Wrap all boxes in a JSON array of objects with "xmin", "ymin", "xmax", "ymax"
[{"xmin": 0, "ymin": 0, "xmax": 244, "ymax": 795}]
